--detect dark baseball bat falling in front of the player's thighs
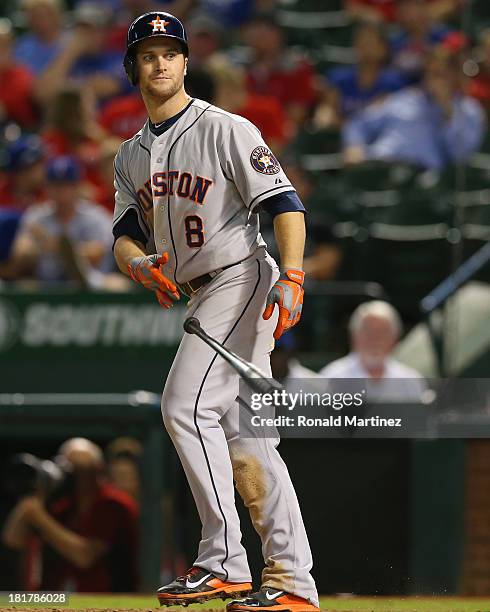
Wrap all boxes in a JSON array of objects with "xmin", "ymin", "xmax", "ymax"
[{"xmin": 184, "ymin": 317, "xmax": 283, "ymax": 393}]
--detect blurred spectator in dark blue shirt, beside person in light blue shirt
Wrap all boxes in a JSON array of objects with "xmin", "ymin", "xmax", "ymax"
[{"xmin": 326, "ymin": 23, "xmax": 407, "ymax": 116}]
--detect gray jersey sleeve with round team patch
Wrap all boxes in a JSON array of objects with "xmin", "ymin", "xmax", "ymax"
[{"xmin": 218, "ymin": 120, "xmax": 294, "ymax": 210}]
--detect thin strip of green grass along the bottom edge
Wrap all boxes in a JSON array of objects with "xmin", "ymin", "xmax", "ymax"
[{"xmin": 0, "ymin": 595, "xmax": 490, "ymax": 612}]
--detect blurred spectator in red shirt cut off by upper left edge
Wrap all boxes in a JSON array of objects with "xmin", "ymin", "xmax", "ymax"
[{"xmin": 0, "ymin": 19, "xmax": 38, "ymax": 129}]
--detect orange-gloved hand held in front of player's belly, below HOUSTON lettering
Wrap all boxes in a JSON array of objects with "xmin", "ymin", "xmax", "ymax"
[{"xmin": 128, "ymin": 253, "xmax": 180, "ymax": 308}]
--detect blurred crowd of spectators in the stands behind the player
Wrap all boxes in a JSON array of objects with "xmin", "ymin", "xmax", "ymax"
[{"xmin": 0, "ymin": 0, "xmax": 490, "ymax": 318}]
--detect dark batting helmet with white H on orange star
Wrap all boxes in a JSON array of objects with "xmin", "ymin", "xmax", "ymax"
[{"xmin": 124, "ymin": 11, "xmax": 189, "ymax": 85}]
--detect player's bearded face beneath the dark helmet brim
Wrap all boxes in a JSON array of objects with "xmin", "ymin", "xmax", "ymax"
[{"xmin": 136, "ymin": 37, "xmax": 187, "ymax": 99}]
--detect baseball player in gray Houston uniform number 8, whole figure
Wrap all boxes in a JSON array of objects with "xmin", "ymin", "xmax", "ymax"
[{"xmin": 113, "ymin": 12, "xmax": 318, "ymax": 612}]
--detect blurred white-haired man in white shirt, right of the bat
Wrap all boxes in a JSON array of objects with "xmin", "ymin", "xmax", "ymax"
[{"xmin": 319, "ymin": 300, "xmax": 426, "ymax": 401}]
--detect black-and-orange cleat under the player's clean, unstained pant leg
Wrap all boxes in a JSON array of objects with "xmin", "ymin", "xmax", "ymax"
[{"xmin": 157, "ymin": 567, "xmax": 252, "ymax": 607}]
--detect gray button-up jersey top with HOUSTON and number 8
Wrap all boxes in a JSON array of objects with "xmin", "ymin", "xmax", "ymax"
[{"xmin": 114, "ymin": 100, "xmax": 293, "ymax": 283}]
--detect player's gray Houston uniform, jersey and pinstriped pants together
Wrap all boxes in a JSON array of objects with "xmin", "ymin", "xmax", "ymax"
[{"xmin": 115, "ymin": 100, "xmax": 318, "ymax": 605}]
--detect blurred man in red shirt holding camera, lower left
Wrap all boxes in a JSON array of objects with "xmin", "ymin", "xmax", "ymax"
[{"xmin": 2, "ymin": 438, "xmax": 138, "ymax": 592}]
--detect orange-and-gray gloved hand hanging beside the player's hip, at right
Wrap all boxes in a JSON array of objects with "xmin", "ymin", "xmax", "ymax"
[{"xmin": 262, "ymin": 269, "xmax": 305, "ymax": 340}]
